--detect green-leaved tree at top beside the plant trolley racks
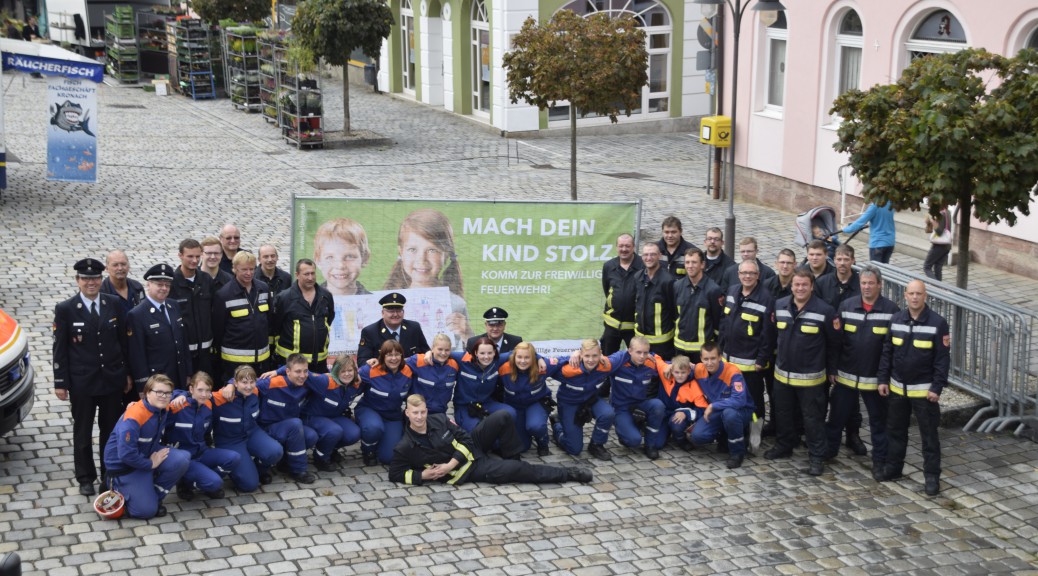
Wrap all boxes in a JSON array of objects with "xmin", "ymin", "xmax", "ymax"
[{"xmin": 292, "ymin": 0, "xmax": 393, "ymax": 134}]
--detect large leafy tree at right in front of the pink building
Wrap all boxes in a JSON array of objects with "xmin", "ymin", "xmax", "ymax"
[{"xmin": 830, "ymin": 49, "xmax": 1038, "ymax": 289}]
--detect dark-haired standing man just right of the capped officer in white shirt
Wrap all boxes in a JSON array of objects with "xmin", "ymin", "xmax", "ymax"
[{"xmin": 169, "ymin": 238, "xmax": 218, "ymax": 376}]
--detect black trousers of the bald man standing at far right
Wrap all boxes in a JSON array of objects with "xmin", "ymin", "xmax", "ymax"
[{"xmin": 886, "ymin": 392, "xmax": 940, "ymax": 476}]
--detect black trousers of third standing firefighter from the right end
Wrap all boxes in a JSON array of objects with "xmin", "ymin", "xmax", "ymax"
[{"xmin": 773, "ymin": 381, "xmax": 827, "ymax": 460}]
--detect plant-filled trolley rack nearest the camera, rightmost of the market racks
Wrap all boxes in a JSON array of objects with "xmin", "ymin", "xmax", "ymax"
[{"xmin": 274, "ymin": 47, "xmax": 324, "ymax": 148}]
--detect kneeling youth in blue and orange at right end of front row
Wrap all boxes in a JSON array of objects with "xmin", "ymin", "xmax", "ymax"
[{"xmin": 688, "ymin": 342, "xmax": 754, "ymax": 468}]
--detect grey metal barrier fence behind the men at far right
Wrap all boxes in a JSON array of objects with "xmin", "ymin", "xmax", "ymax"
[{"xmin": 871, "ymin": 263, "xmax": 1038, "ymax": 436}]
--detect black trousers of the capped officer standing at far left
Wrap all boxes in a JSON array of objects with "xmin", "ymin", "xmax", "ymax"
[{"xmin": 69, "ymin": 389, "xmax": 122, "ymax": 484}]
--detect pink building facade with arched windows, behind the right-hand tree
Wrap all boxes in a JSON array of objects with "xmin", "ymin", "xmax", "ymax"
[{"xmin": 723, "ymin": 0, "xmax": 1038, "ymax": 277}]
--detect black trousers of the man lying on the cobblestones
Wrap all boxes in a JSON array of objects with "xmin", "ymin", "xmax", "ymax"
[{"xmin": 466, "ymin": 410, "xmax": 569, "ymax": 484}]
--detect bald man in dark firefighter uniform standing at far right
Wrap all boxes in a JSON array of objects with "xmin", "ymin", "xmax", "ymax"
[{"xmin": 878, "ymin": 280, "xmax": 951, "ymax": 496}]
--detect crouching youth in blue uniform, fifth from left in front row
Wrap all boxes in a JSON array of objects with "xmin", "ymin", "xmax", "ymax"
[{"xmin": 302, "ymin": 354, "xmax": 361, "ymax": 472}]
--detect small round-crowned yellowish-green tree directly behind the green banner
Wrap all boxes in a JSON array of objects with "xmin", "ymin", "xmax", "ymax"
[{"xmin": 503, "ymin": 10, "xmax": 649, "ymax": 200}]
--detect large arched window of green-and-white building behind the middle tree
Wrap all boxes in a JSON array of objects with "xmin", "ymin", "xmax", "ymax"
[{"xmin": 548, "ymin": 0, "xmax": 673, "ymax": 121}]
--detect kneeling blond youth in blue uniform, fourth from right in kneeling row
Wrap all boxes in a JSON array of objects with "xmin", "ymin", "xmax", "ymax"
[{"xmin": 551, "ymin": 338, "xmax": 627, "ymax": 460}]
